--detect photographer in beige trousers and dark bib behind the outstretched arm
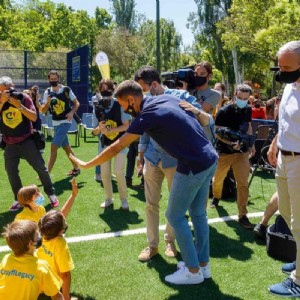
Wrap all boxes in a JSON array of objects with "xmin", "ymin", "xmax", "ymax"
[{"xmin": 93, "ymin": 79, "xmax": 131, "ymax": 210}]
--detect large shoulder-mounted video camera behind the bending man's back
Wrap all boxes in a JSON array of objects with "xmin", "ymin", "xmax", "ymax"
[{"xmin": 161, "ymin": 66, "xmax": 195, "ymax": 89}]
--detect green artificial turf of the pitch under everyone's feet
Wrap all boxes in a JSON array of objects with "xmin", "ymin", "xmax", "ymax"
[{"xmin": 0, "ymin": 136, "xmax": 285, "ymax": 300}]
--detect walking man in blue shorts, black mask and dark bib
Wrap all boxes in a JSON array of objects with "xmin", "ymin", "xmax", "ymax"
[{"xmin": 41, "ymin": 70, "xmax": 80, "ymax": 176}]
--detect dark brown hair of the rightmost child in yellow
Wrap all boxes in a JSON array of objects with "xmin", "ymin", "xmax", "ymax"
[{"xmin": 39, "ymin": 210, "xmax": 65, "ymax": 240}]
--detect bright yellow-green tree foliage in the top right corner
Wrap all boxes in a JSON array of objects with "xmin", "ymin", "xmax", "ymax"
[{"xmin": 218, "ymin": 0, "xmax": 300, "ymax": 61}]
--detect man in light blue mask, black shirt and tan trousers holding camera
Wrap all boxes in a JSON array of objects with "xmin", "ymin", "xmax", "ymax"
[{"xmin": 210, "ymin": 84, "xmax": 255, "ymax": 229}]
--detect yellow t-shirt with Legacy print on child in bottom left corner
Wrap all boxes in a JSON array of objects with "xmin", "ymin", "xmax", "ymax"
[{"xmin": 0, "ymin": 253, "xmax": 62, "ymax": 300}]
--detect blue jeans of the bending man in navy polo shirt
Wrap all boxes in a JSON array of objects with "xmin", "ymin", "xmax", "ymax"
[{"xmin": 166, "ymin": 163, "xmax": 216, "ymax": 268}]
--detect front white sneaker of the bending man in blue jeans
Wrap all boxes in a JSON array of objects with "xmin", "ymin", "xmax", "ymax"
[{"xmin": 165, "ymin": 266, "xmax": 204, "ymax": 284}]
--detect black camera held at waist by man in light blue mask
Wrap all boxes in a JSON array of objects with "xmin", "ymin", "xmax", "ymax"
[{"xmin": 216, "ymin": 127, "xmax": 256, "ymax": 148}]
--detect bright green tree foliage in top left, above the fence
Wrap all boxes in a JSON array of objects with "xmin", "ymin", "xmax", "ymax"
[{"xmin": 0, "ymin": 0, "xmax": 97, "ymax": 52}]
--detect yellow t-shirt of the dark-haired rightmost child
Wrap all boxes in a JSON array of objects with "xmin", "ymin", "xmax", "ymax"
[{"xmin": 37, "ymin": 236, "xmax": 74, "ymax": 276}]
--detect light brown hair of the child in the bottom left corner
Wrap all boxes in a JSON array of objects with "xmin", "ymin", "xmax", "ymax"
[{"xmin": 2, "ymin": 220, "xmax": 38, "ymax": 256}]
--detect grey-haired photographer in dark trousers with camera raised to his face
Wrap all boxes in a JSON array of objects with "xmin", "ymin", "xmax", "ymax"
[{"xmin": 0, "ymin": 76, "xmax": 59, "ymax": 211}]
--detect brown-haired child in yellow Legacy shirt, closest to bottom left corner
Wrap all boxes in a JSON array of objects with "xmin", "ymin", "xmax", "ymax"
[{"xmin": 0, "ymin": 220, "xmax": 63, "ymax": 300}]
